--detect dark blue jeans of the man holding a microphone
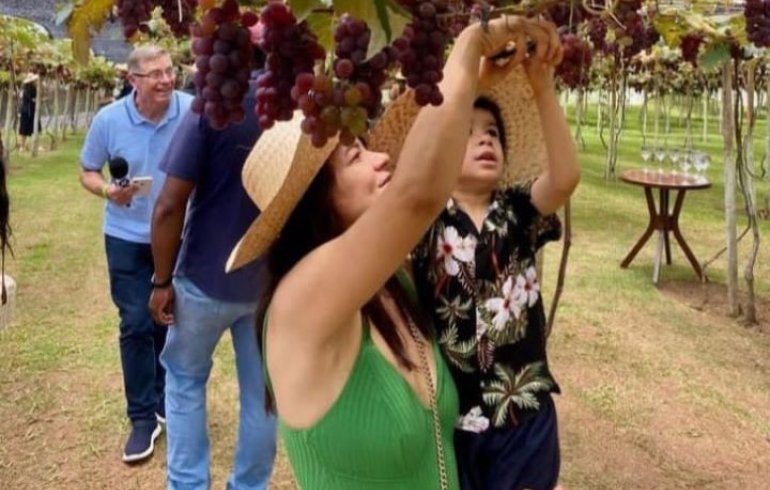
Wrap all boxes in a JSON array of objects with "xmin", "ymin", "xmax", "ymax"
[{"xmin": 104, "ymin": 235, "xmax": 166, "ymax": 427}]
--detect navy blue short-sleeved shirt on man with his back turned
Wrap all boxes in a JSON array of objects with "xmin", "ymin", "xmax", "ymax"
[{"xmin": 160, "ymin": 82, "xmax": 263, "ymax": 303}]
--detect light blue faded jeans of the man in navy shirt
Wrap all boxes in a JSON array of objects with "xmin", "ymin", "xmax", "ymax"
[{"xmin": 161, "ymin": 277, "xmax": 276, "ymax": 490}]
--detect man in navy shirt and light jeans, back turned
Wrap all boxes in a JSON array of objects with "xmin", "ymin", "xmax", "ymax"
[{"xmin": 150, "ymin": 55, "xmax": 276, "ymax": 490}]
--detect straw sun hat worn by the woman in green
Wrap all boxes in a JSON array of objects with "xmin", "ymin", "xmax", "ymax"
[{"xmin": 226, "ymin": 114, "xmax": 338, "ymax": 272}]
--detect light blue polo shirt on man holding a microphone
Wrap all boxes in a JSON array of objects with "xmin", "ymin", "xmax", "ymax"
[{"xmin": 80, "ymin": 91, "xmax": 193, "ymax": 243}]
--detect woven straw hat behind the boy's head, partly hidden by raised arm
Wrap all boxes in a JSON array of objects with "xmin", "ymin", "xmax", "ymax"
[{"xmin": 369, "ymin": 66, "xmax": 548, "ymax": 186}]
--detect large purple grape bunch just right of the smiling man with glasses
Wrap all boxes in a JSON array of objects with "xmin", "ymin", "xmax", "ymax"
[{"xmin": 191, "ymin": 0, "xmax": 257, "ymax": 129}]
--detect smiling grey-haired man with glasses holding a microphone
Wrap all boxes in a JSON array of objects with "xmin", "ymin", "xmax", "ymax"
[{"xmin": 80, "ymin": 46, "xmax": 192, "ymax": 463}]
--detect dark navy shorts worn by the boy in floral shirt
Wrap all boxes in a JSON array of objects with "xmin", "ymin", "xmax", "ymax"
[{"xmin": 455, "ymin": 397, "xmax": 560, "ymax": 490}]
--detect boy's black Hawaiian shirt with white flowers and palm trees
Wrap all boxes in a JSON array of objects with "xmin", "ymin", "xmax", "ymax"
[{"xmin": 412, "ymin": 182, "xmax": 561, "ymax": 432}]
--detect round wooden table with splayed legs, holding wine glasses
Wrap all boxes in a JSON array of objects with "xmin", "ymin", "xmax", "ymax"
[{"xmin": 620, "ymin": 169, "xmax": 711, "ymax": 284}]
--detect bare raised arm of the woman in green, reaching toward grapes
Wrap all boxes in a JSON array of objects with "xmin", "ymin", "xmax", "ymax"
[{"xmin": 270, "ymin": 17, "xmax": 558, "ymax": 341}]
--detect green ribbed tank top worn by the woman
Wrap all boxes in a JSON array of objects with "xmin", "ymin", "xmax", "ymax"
[{"xmin": 265, "ymin": 272, "xmax": 460, "ymax": 490}]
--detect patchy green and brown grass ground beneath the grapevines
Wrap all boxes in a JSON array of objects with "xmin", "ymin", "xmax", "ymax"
[{"xmin": 0, "ymin": 103, "xmax": 770, "ymax": 490}]
